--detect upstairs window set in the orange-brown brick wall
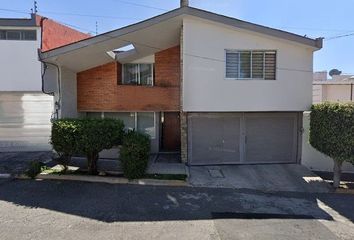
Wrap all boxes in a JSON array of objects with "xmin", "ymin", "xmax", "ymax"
[{"xmin": 122, "ymin": 63, "xmax": 154, "ymax": 86}]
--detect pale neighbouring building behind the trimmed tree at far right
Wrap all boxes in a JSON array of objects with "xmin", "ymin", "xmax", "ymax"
[{"xmin": 313, "ymin": 71, "xmax": 354, "ymax": 103}]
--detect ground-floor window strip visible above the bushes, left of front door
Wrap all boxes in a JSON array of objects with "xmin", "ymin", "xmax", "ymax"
[{"xmin": 87, "ymin": 112, "xmax": 156, "ymax": 139}]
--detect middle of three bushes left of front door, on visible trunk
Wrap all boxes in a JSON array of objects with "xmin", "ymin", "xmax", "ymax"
[{"xmin": 78, "ymin": 118, "xmax": 124, "ymax": 175}]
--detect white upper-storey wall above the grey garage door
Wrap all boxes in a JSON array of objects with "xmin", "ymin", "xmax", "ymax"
[{"xmin": 182, "ymin": 17, "xmax": 315, "ymax": 112}]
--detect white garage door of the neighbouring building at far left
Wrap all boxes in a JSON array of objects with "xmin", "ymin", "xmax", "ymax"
[{"xmin": 0, "ymin": 92, "xmax": 53, "ymax": 152}]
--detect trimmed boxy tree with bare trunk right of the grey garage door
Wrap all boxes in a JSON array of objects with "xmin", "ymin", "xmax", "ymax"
[{"xmin": 310, "ymin": 103, "xmax": 354, "ymax": 187}]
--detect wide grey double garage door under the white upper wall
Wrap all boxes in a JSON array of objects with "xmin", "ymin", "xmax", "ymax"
[{"xmin": 188, "ymin": 113, "xmax": 298, "ymax": 165}]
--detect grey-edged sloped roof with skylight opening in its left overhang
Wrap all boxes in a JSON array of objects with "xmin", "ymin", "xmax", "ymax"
[{"xmin": 40, "ymin": 7, "xmax": 322, "ymax": 72}]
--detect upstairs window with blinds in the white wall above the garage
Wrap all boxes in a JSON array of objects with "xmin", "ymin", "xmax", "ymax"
[{"xmin": 225, "ymin": 50, "xmax": 276, "ymax": 80}]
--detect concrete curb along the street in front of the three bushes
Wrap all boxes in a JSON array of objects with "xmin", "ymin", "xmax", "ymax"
[{"xmin": 30, "ymin": 174, "xmax": 189, "ymax": 187}]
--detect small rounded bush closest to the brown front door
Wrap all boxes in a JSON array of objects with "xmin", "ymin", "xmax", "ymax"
[{"xmin": 120, "ymin": 131, "xmax": 150, "ymax": 179}]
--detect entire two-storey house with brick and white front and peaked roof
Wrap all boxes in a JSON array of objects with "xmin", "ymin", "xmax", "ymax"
[{"xmin": 41, "ymin": 4, "xmax": 322, "ymax": 165}]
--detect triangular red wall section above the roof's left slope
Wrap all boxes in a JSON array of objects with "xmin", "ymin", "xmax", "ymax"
[{"xmin": 36, "ymin": 15, "xmax": 91, "ymax": 52}]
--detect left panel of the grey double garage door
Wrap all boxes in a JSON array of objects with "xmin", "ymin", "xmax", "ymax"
[{"xmin": 188, "ymin": 113, "xmax": 242, "ymax": 165}]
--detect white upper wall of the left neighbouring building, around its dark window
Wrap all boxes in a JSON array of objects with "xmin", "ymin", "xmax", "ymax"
[{"xmin": 0, "ymin": 26, "xmax": 42, "ymax": 92}]
